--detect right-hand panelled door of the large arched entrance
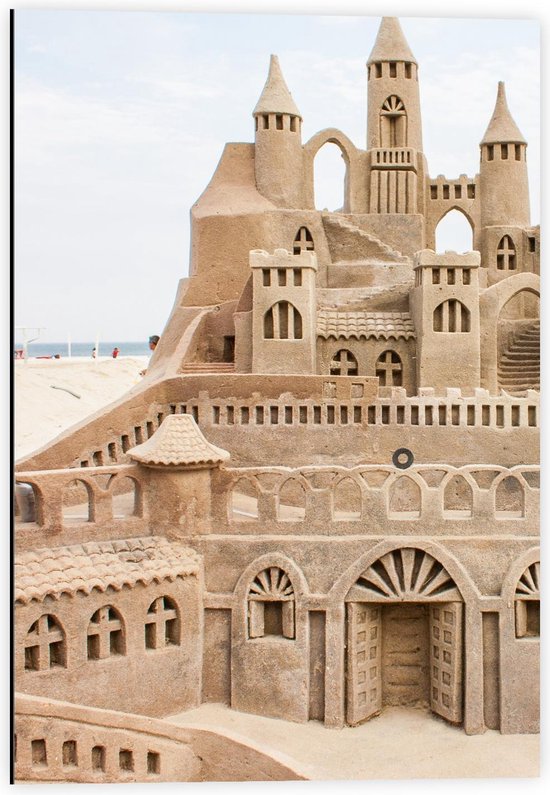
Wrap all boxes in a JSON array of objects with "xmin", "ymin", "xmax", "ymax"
[{"xmin": 430, "ymin": 602, "xmax": 463, "ymax": 723}]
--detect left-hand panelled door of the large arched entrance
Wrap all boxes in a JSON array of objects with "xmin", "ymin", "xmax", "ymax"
[{"xmin": 346, "ymin": 602, "xmax": 382, "ymax": 726}]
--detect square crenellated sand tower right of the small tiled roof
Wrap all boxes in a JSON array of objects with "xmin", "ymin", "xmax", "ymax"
[{"xmin": 410, "ymin": 249, "xmax": 481, "ymax": 395}]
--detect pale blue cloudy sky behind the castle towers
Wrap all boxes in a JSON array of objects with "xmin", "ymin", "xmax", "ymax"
[{"xmin": 15, "ymin": 0, "xmax": 540, "ymax": 341}]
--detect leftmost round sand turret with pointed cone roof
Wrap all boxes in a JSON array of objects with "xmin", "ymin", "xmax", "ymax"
[{"xmin": 253, "ymin": 55, "xmax": 304, "ymax": 208}]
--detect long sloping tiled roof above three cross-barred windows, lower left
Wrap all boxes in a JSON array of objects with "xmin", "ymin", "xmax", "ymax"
[{"xmin": 15, "ymin": 536, "xmax": 199, "ymax": 604}]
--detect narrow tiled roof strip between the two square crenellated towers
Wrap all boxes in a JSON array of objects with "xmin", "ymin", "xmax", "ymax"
[{"xmin": 317, "ymin": 308, "xmax": 416, "ymax": 339}]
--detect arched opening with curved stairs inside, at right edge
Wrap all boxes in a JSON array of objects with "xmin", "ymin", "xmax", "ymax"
[{"xmin": 497, "ymin": 289, "xmax": 540, "ymax": 395}]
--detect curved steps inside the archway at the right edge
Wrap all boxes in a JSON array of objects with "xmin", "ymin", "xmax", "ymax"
[{"xmin": 498, "ymin": 321, "xmax": 540, "ymax": 395}]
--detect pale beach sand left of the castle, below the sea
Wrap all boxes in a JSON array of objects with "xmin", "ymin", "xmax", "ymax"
[{"xmin": 14, "ymin": 356, "xmax": 149, "ymax": 460}]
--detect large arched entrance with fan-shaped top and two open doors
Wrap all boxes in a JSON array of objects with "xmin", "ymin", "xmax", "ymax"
[{"xmin": 345, "ymin": 546, "xmax": 464, "ymax": 726}]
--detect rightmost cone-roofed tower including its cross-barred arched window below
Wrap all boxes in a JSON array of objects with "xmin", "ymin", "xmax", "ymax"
[{"xmin": 479, "ymin": 82, "xmax": 532, "ymax": 283}]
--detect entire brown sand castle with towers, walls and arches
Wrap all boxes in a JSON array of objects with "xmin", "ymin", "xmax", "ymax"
[{"xmin": 15, "ymin": 18, "xmax": 540, "ymax": 781}]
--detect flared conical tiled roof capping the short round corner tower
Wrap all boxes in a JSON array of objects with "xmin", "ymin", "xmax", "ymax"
[{"xmin": 128, "ymin": 414, "xmax": 229, "ymax": 469}]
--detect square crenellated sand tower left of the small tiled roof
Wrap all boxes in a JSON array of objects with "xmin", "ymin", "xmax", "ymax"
[{"xmin": 250, "ymin": 249, "xmax": 317, "ymax": 374}]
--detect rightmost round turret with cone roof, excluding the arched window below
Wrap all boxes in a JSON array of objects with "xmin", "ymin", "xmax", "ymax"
[{"xmin": 479, "ymin": 82, "xmax": 530, "ymax": 227}]
